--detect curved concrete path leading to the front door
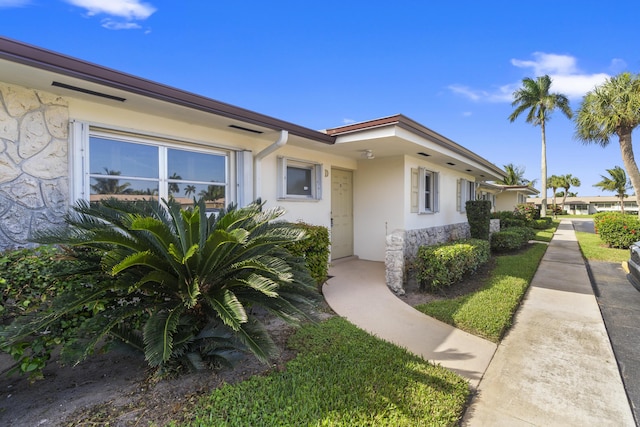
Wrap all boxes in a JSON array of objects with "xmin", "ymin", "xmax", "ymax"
[{"xmin": 322, "ymin": 260, "xmax": 496, "ymax": 388}]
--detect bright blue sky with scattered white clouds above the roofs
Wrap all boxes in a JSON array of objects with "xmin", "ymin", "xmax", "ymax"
[{"xmin": 0, "ymin": 0, "xmax": 640, "ymax": 196}]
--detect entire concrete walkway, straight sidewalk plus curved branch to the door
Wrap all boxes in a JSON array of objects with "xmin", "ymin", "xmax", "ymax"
[{"xmin": 323, "ymin": 220, "xmax": 635, "ymax": 427}]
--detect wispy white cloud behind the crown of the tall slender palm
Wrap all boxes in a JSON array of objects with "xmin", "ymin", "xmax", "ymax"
[{"xmin": 449, "ymin": 52, "xmax": 608, "ymax": 102}]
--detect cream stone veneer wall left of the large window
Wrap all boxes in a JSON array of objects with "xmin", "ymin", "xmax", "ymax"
[{"xmin": 0, "ymin": 83, "xmax": 69, "ymax": 250}]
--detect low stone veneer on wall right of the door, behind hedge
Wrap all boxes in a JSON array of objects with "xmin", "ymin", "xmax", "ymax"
[{"xmin": 385, "ymin": 219, "xmax": 500, "ymax": 295}]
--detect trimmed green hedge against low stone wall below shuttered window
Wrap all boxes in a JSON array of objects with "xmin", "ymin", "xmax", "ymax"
[{"xmin": 415, "ymin": 239, "xmax": 491, "ymax": 289}]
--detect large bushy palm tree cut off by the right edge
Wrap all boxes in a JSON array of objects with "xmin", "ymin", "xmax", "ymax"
[{"xmin": 575, "ymin": 73, "xmax": 640, "ymax": 217}]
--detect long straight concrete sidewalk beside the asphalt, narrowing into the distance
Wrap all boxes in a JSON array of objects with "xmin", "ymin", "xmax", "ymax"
[{"xmin": 463, "ymin": 220, "xmax": 635, "ymax": 427}]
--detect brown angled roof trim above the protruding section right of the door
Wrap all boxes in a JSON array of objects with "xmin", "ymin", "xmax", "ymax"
[{"xmin": 326, "ymin": 114, "xmax": 505, "ymax": 176}]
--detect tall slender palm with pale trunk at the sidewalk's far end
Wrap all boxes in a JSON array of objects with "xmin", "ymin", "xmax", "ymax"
[{"xmin": 509, "ymin": 74, "xmax": 573, "ymax": 216}]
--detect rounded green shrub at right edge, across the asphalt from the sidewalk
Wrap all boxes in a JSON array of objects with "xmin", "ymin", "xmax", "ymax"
[{"xmin": 594, "ymin": 212, "xmax": 640, "ymax": 249}]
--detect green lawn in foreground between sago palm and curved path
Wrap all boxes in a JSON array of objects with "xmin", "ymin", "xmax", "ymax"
[{"xmin": 180, "ymin": 318, "xmax": 469, "ymax": 427}]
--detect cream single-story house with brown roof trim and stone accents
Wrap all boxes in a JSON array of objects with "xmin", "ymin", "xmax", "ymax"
[{"xmin": 0, "ymin": 38, "xmax": 504, "ymax": 292}]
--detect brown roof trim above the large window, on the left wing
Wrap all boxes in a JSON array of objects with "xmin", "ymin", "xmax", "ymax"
[{"xmin": 0, "ymin": 37, "xmax": 335, "ymax": 144}]
